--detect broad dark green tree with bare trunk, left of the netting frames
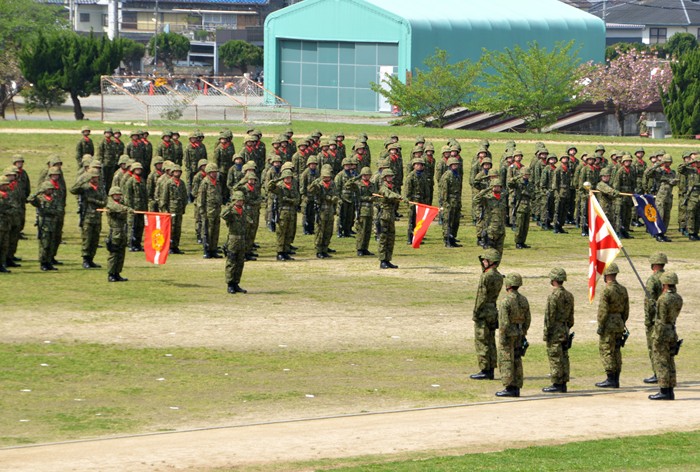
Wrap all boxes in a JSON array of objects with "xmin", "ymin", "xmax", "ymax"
[{"xmin": 19, "ymin": 31, "xmax": 122, "ymax": 120}]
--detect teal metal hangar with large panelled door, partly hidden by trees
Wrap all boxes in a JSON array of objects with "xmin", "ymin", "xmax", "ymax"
[{"xmin": 265, "ymin": 0, "xmax": 605, "ymax": 111}]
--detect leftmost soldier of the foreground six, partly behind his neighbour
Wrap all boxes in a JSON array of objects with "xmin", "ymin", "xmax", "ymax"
[{"xmin": 469, "ymin": 249, "xmax": 503, "ymax": 380}]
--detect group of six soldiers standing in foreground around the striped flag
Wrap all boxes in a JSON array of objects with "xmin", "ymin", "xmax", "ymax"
[{"xmin": 470, "ymin": 249, "xmax": 683, "ymax": 400}]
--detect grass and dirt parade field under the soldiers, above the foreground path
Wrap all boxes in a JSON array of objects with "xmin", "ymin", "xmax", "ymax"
[{"xmin": 0, "ymin": 121, "xmax": 700, "ymax": 464}]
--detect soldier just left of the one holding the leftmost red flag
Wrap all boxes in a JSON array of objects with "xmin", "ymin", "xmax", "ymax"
[{"xmin": 70, "ymin": 169, "xmax": 107, "ymax": 269}]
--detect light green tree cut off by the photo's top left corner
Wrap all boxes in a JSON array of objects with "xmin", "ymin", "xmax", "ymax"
[{"xmin": 0, "ymin": 0, "xmax": 67, "ymax": 118}]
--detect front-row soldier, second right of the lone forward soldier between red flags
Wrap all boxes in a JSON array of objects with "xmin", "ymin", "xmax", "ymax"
[{"xmin": 267, "ymin": 170, "xmax": 301, "ymax": 261}]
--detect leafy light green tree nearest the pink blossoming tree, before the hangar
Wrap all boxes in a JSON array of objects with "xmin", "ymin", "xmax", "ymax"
[{"xmin": 475, "ymin": 41, "xmax": 582, "ymax": 132}]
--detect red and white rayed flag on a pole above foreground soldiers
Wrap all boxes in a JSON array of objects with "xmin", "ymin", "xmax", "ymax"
[{"xmin": 588, "ymin": 193, "xmax": 622, "ymax": 303}]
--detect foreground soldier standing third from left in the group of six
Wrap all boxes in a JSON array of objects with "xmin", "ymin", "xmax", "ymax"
[{"xmin": 542, "ymin": 267, "xmax": 574, "ymax": 393}]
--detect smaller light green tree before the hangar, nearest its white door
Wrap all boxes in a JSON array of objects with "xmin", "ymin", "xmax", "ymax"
[{"xmin": 370, "ymin": 49, "xmax": 481, "ymax": 127}]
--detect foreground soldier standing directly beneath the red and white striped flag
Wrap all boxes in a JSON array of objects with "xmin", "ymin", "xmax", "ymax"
[{"xmin": 595, "ymin": 262, "xmax": 630, "ymax": 388}]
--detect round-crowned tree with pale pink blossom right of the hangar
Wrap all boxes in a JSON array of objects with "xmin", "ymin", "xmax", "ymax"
[{"xmin": 583, "ymin": 49, "xmax": 672, "ymax": 136}]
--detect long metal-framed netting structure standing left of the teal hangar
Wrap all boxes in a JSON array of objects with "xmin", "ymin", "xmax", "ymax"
[{"xmin": 101, "ymin": 76, "xmax": 292, "ymax": 126}]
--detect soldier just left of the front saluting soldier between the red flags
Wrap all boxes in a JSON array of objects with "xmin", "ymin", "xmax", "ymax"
[{"xmin": 197, "ymin": 162, "xmax": 223, "ymax": 259}]
